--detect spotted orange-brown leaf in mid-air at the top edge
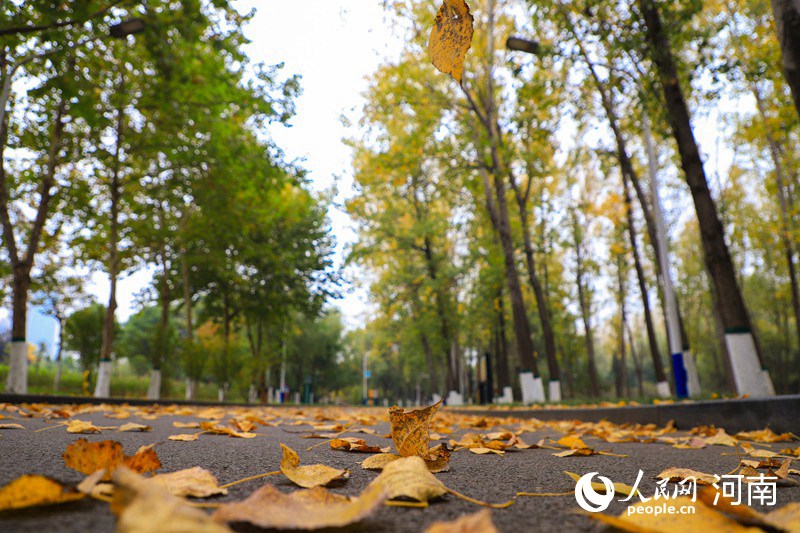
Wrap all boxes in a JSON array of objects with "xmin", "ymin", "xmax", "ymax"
[{"xmin": 428, "ymin": 0, "xmax": 473, "ymax": 83}]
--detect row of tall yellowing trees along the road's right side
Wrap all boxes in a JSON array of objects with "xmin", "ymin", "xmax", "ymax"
[{"xmin": 348, "ymin": 0, "xmax": 800, "ymax": 401}]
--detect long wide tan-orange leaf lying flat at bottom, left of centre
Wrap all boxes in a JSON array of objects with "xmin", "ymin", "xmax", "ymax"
[{"xmin": 214, "ymin": 485, "xmax": 386, "ymax": 530}]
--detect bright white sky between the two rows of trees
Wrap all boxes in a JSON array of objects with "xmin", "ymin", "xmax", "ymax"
[{"xmin": 92, "ymin": 0, "xmax": 402, "ymax": 327}]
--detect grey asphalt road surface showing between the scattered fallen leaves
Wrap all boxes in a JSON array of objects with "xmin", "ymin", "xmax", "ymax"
[{"xmin": 0, "ymin": 404, "xmax": 800, "ymax": 533}]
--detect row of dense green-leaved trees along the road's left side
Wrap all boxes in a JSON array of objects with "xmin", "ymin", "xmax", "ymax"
[{"xmin": 0, "ymin": 0, "xmax": 336, "ymax": 398}]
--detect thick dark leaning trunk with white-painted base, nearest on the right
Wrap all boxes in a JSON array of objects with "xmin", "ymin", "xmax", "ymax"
[{"xmin": 638, "ymin": 0, "xmax": 774, "ymax": 396}]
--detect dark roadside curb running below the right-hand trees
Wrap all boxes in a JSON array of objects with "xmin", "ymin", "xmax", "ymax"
[{"xmin": 451, "ymin": 394, "xmax": 800, "ymax": 435}]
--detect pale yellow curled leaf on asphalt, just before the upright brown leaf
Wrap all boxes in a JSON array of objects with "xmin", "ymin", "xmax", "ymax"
[{"xmin": 371, "ymin": 457, "xmax": 447, "ymax": 502}]
